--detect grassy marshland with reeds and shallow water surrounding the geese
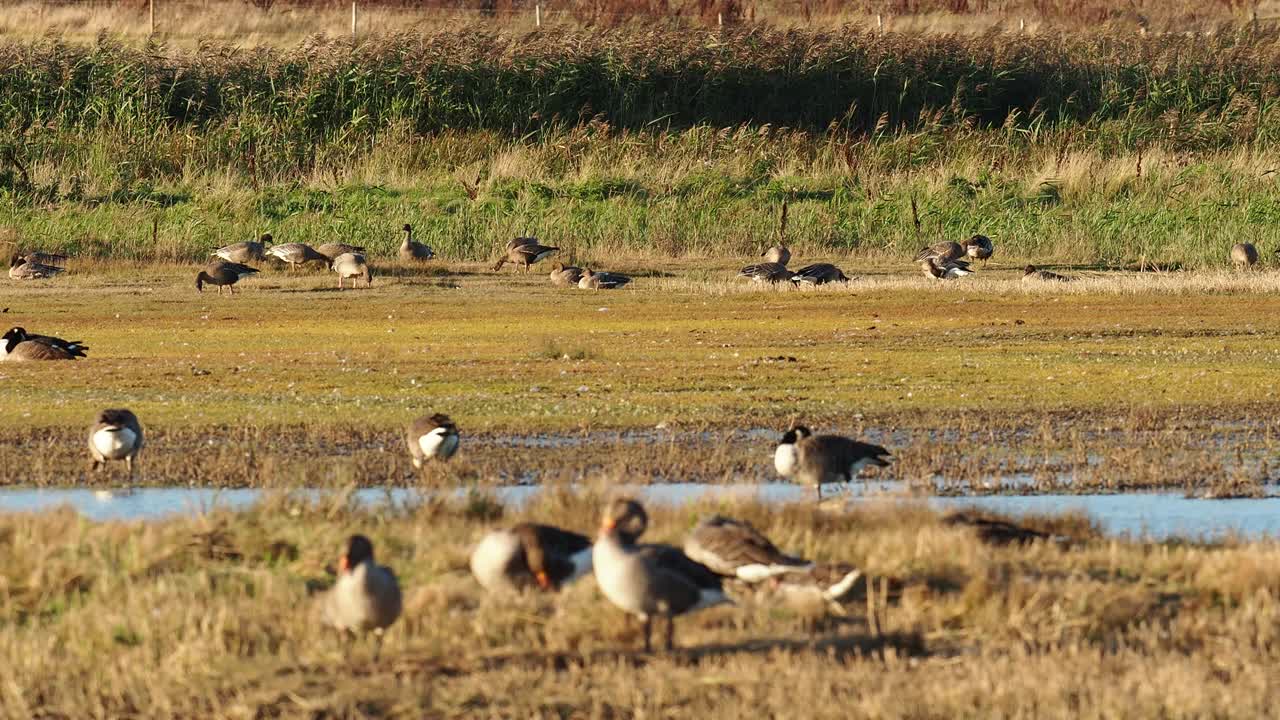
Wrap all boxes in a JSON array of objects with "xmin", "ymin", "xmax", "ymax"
[{"xmin": 0, "ymin": 9, "xmax": 1280, "ymax": 717}]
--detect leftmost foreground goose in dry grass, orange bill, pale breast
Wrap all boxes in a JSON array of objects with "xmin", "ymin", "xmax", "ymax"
[{"xmin": 323, "ymin": 536, "xmax": 401, "ymax": 660}]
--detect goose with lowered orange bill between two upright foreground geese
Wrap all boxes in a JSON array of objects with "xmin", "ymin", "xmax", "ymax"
[{"xmin": 471, "ymin": 523, "xmax": 591, "ymax": 592}]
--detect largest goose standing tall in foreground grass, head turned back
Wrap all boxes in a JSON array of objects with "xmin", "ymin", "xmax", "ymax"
[{"xmin": 591, "ymin": 498, "xmax": 728, "ymax": 652}]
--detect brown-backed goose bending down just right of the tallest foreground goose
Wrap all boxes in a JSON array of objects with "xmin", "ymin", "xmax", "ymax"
[{"xmin": 685, "ymin": 515, "xmax": 813, "ymax": 583}]
